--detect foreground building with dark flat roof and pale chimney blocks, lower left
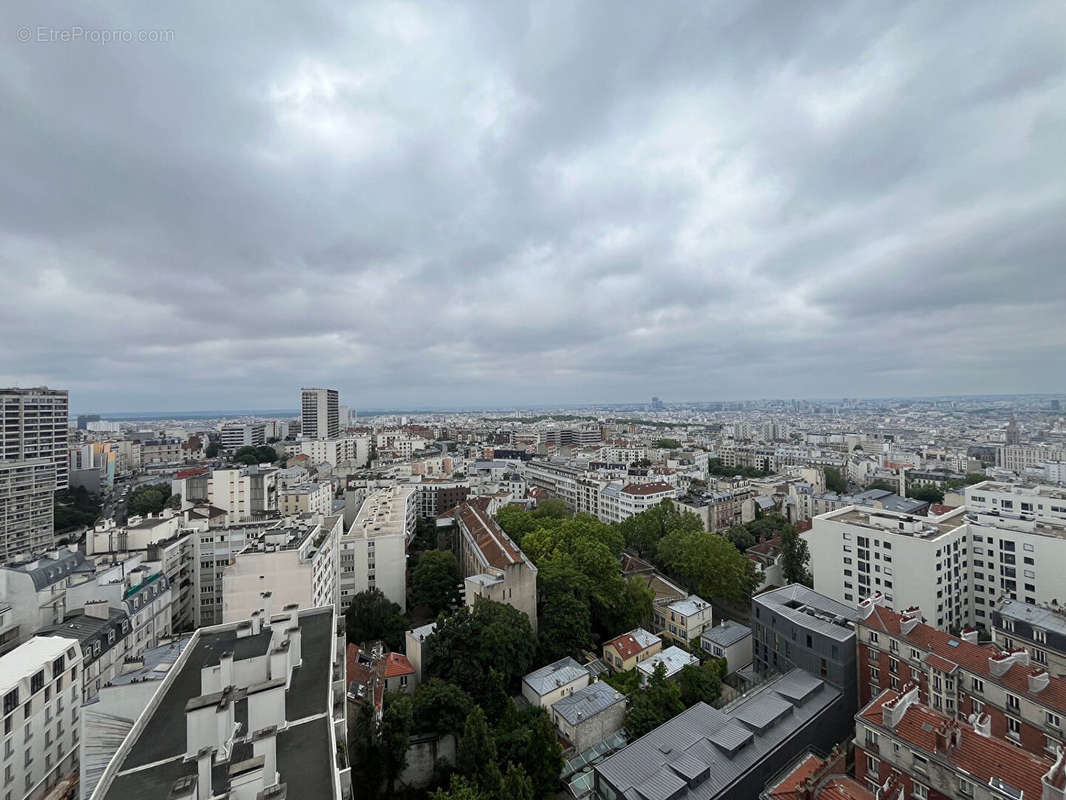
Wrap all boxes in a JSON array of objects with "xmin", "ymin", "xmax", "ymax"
[{"xmin": 81, "ymin": 598, "xmax": 351, "ymax": 800}]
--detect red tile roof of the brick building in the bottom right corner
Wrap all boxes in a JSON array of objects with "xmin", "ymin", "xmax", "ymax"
[{"xmin": 859, "ymin": 689, "xmax": 1062, "ymax": 798}]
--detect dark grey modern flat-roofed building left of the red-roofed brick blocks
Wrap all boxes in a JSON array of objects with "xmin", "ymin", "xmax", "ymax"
[{"xmin": 752, "ymin": 583, "xmax": 857, "ymax": 714}]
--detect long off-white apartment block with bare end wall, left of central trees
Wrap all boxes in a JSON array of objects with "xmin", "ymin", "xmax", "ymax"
[{"xmin": 339, "ymin": 485, "xmax": 418, "ymax": 611}]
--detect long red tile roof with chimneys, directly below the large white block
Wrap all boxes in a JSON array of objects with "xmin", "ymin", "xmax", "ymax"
[{"xmin": 859, "ymin": 606, "xmax": 1066, "ymax": 713}]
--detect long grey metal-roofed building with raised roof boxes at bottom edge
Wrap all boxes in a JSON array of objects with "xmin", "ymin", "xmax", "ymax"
[{"xmin": 593, "ymin": 670, "xmax": 852, "ymax": 800}]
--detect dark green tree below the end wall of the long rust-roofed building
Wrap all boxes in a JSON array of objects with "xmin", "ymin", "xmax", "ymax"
[{"xmin": 422, "ymin": 597, "xmax": 536, "ymax": 702}]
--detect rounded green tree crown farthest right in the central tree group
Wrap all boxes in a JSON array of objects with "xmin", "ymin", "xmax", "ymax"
[{"xmin": 657, "ymin": 530, "xmax": 760, "ymax": 605}]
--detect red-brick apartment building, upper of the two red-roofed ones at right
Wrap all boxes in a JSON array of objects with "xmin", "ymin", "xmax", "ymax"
[{"xmin": 857, "ymin": 597, "xmax": 1066, "ymax": 756}]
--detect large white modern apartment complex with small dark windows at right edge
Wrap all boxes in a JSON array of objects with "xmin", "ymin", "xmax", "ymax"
[{"xmin": 804, "ymin": 481, "xmax": 1066, "ymax": 628}]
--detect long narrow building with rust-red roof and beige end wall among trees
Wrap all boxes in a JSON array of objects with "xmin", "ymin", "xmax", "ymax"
[{"xmin": 452, "ymin": 501, "xmax": 537, "ymax": 633}]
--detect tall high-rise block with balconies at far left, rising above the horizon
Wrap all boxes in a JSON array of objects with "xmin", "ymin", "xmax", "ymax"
[{"xmin": 0, "ymin": 386, "xmax": 69, "ymax": 491}]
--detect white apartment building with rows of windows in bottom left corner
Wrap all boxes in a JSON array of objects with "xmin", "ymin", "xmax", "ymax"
[{"xmin": 0, "ymin": 636, "xmax": 82, "ymax": 800}]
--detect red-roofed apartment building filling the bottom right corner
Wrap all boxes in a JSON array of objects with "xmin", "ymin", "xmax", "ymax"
[{"xmin": 855, "ymin": 687, "xmax": 1066, "ymax": 800}]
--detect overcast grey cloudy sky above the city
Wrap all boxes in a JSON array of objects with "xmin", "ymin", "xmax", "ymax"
[{"xmin": 0, "ymin": 0, "xmax": 1066, "ymax": 411}]
